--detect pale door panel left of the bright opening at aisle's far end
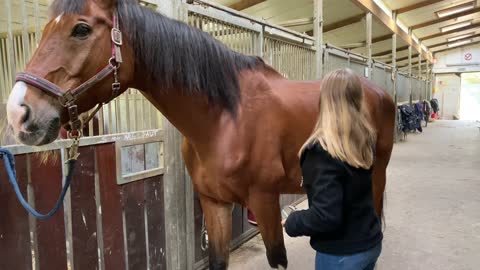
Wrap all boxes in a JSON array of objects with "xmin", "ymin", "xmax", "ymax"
[{"xmin": 433, "ymin": 74, "xmax": 461, "ymax": 120}]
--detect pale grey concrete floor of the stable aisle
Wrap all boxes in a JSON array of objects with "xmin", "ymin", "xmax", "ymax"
[{"xmin": 229, "ymin": 121, "xmax": 480, "ymax": 270}]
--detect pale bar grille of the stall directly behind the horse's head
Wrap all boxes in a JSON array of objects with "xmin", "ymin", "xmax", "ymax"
[{"xmin": 0, "ymin": 0, "xmax": 161, "ymax": 144}]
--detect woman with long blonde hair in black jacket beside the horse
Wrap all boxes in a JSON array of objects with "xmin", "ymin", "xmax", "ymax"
[{"xmin": 284, "ymin": 69, "xmax": 383, "ymax": 270}]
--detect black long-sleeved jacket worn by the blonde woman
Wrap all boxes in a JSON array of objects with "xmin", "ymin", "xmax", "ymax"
[{"xmin": 285, "ymin": 143, "xmax": 383, "ymax": 255}]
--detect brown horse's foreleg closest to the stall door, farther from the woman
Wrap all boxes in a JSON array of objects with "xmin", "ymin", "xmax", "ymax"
[{"xmin": 200, "ymin": 195, "xmax": 232, "ymax": 270}]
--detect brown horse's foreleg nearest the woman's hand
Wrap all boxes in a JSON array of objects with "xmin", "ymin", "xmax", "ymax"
[{"xmin": 248, "ymin": 193, "xmax": 288, "ymax": 269}]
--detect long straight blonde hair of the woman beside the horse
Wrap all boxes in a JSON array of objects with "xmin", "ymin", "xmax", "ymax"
[{"xmin": 300, "ymin": 69, "xmax": 376, "ymax": 169}]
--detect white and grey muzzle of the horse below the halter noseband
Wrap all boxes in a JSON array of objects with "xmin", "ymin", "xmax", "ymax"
[{"xmin": 7, "ymin": 82, "xmax": 60, "ymax": 145}]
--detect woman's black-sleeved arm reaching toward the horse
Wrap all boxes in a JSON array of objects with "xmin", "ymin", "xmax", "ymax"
[{"xmin": 285, "ymin": 146, "xmax": 346, "ymax": 237}]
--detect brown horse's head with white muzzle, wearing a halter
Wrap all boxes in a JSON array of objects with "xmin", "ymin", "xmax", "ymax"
[{"xmin": 7, "ymin": 0, "xmax": 133, "ymax": 145}]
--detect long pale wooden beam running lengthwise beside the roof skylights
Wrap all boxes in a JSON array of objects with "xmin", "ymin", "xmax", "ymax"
[{"xmin": 352, "ymin": 0, "xmax": 432, "ymax": 61}]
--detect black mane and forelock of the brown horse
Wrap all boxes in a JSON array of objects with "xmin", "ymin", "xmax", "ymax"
[{"xmin": 50, "ymin": 0, "xmax": 263, "ymax": 114}]
